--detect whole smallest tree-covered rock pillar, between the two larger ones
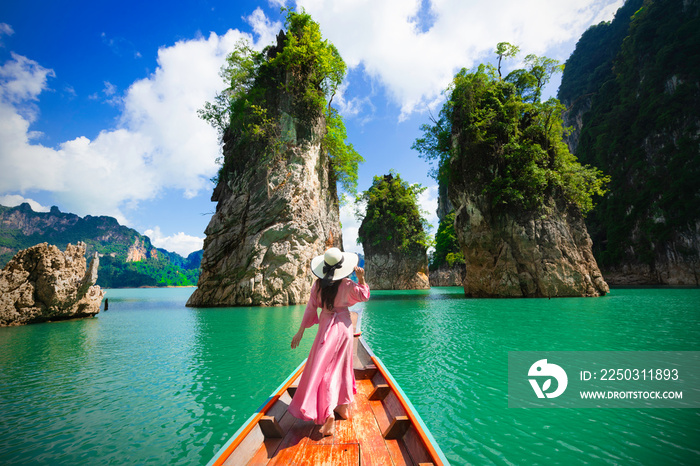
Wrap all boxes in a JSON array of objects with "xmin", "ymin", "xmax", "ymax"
[{"xmin": 357, "ymin": 173, "xmax": 430, "ymax": 290}]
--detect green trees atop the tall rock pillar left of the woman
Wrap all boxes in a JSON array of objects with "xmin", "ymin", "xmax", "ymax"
[{"xmin": 199, "ymin": 10, "xmax": 363, "ymax": 193}]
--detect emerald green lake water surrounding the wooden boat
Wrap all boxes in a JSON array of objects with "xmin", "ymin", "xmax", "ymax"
[{"xmin": 0, "ymin": 288, "xmax": 700, "ymax": 465}]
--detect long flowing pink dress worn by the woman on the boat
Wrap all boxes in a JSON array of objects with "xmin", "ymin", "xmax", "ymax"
[{"xmin": 288, "ymin": 278, "xmax": 369, "ymax": 424}]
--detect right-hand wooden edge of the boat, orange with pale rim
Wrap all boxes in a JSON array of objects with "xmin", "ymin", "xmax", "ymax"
[{"xmin": 356, "ymin": 337, "xmax": 450, "ymax": 466}]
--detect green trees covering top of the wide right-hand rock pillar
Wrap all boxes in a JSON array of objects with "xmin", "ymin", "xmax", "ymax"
[{"xmin": 413, "ymin": 43, "xmax": 608, "ymax": 213}]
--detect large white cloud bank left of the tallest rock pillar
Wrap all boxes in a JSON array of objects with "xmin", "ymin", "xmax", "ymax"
[{"xmin": 0, "ymin": 10, "xmax": 281, "ymax": 224}]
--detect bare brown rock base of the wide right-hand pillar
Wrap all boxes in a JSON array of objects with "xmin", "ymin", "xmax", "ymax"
[{"xmin": 452, "ymin": 193, "xmax": 609, "ymax": 298}]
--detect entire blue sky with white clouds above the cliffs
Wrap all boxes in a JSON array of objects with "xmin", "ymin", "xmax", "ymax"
[{"xmin": 0, "ymin": 0, "xmax": 623, "ymax": 255}]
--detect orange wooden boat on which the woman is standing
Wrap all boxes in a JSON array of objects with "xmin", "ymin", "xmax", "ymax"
[{"xmin": 208, "ymin": 313, "xmax": 449, "ymax": 466}]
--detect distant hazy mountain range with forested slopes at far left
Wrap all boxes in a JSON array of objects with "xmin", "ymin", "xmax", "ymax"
[{"xmin": 0, "ymin": 203, "xmax": 202, "ymax": 288}]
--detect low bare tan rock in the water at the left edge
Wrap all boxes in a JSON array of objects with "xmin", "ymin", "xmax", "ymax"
[{"xmin": 0, "ymin": 243, "xmax": 104, "ymax": 326}]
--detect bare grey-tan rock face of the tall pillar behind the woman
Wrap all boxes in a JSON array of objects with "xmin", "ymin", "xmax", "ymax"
[{"xmin": 187, "ymin": 33, "xmax": 342, "ymax": 307}]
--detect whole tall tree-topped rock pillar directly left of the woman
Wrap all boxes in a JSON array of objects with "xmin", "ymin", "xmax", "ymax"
[{"xmin": 187, "ymin": 10, "xmax": 362, "ymax": 306}]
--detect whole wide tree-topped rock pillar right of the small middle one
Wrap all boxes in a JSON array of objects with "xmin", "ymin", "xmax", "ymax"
[{"xmin": 414, "ymin": 43, "xmax": 608, "ymax": 297}]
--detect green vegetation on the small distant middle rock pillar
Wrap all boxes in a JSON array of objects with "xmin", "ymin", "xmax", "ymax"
[{"xmin": 356, "ymin": 172, "xmax": 430, "ymax": 255}]
